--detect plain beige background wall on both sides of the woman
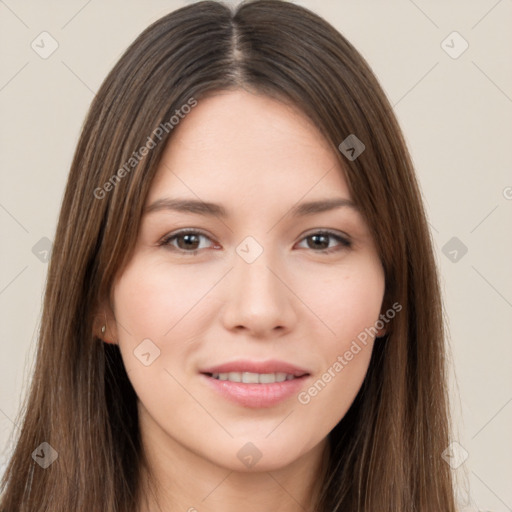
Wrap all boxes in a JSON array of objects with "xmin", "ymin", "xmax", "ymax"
[{"xmin": 0, "ymin": 0, "xmax": 512, "ymax": 512}]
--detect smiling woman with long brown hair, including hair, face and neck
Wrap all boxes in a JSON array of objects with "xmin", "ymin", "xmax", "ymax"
[{"xmin": 1, "ymin": 0, "xmax": 455, "ymax": 512}]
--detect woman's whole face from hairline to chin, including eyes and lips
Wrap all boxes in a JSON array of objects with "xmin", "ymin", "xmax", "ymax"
[{"xmin": 109, "ymin": 90, "xmax": 384, "ymax": 471}]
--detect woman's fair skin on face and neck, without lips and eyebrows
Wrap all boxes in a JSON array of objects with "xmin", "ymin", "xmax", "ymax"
[{"xmin": 97, "ymin": 90, "xmax": 385, "ymax": 512}]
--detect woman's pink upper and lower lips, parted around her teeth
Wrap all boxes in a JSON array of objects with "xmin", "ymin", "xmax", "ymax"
[{"xmin": 201, "ymin": 360, "xmax": 310, "ymax": 408}]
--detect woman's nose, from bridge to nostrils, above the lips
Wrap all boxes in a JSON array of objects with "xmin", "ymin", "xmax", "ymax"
[{"xmin": 223, "ymin": 246, "xmax": 297, "ymax": 338}]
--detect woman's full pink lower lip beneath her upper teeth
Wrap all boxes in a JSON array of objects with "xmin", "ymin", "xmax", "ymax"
[{"xmin": 201, "ymin": 373, "xmax": 308, "ymax": 408}]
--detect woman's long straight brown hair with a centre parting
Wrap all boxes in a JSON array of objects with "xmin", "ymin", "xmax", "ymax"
[{"xmin": 1, "ymin": 0, "xmax": 455, "ymax": 512}]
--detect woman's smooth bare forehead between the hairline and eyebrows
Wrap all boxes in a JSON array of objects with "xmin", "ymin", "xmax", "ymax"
[{"xmin": 147, "ymin": 90, "xmax": 350, "ymax": 211}]
